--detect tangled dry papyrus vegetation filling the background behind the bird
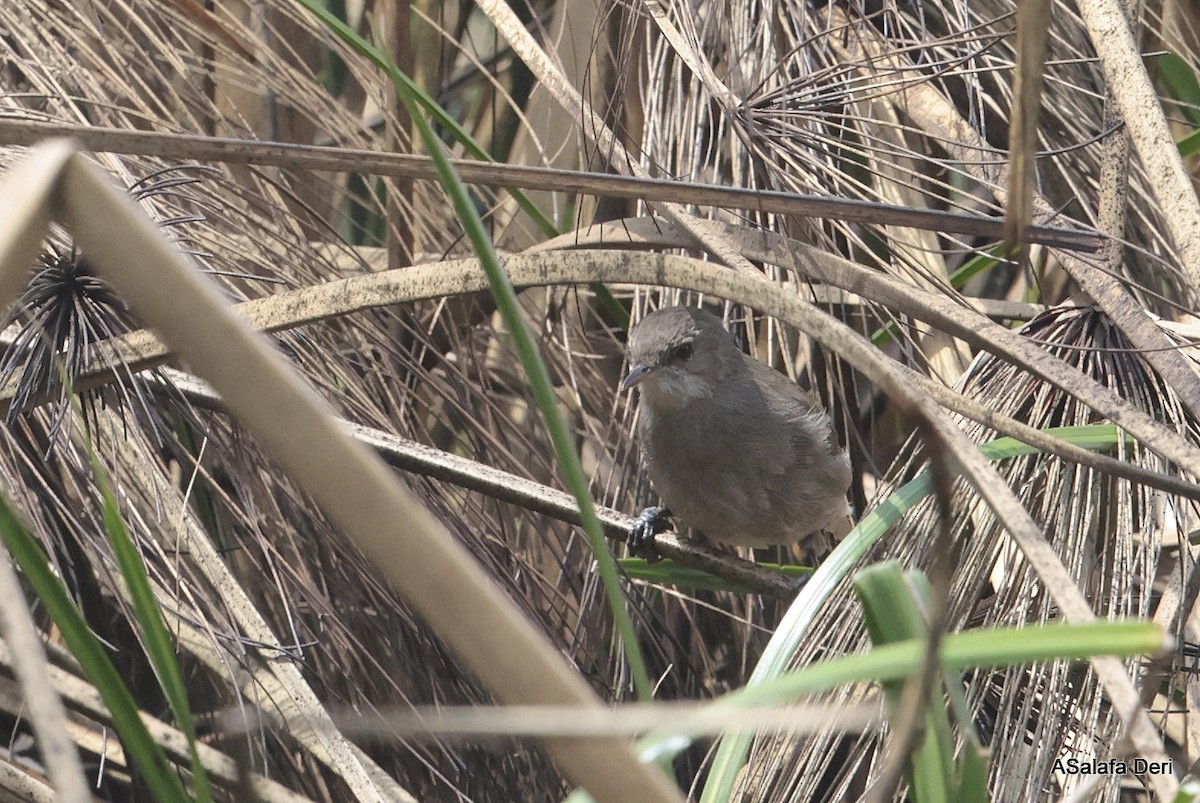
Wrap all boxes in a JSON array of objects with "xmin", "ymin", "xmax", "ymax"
[{"xmin": 0, "ymin": 0, "xmax": 1200, "ymax": 802}]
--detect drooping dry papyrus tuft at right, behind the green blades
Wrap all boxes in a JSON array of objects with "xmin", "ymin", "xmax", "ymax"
[{"xmin": 734, "ymin": 304, "xmax": 1200, "ymax": 801}]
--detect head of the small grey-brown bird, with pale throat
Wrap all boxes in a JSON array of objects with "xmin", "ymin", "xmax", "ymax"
[{"xmin": 620, "ymin": 306, "xmax": 742, "ymax": 407}]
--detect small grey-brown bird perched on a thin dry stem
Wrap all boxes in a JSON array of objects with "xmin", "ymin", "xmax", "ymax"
[{"xmin": 622, "ymin": 306, "xmax": 850, "ymax": 557}]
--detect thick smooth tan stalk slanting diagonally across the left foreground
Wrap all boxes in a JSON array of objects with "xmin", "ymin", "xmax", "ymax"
[{"xmin": 14, "ymin": 143, "xmax": 678, "ymax": 801}]
